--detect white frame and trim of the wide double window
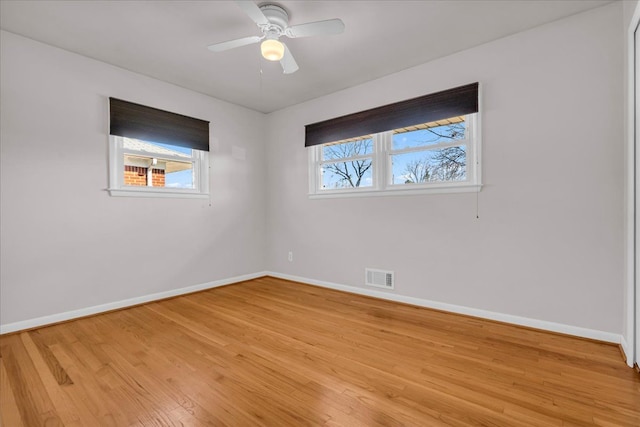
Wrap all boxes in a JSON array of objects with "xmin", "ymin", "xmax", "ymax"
[{"xmin": 308, "ymin": 112, "xmax": 482, "ymax": 199}]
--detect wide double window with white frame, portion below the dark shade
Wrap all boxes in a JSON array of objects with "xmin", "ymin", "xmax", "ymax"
[{"xmin": 309, "ymin": 113, "xmax": 480, "ymax": 196}]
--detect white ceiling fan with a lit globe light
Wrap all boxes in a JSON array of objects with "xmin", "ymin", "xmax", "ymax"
[{"xmin": 209, "ymin": 0, "xmax": 344, "ymax": 74}]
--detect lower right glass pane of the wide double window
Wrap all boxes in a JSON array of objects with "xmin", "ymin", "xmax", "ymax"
[{"xmin": 391, "ymin": 146, "xmax": 467, "ymax": 184}]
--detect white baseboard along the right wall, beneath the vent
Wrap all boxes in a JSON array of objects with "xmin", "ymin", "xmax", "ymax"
[{"xmin": 266, "ymin": 271, "xmax": 629, "ymax": 346}]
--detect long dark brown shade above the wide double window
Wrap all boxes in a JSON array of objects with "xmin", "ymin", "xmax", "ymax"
[{"xmin": 304, "ymin": 83, "xmax": 479, "ymax": 147}]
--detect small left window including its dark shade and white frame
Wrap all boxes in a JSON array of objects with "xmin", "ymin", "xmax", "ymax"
[{"xmin": 109, "ymin": 98, "xmax": 209, "ymax": 198}]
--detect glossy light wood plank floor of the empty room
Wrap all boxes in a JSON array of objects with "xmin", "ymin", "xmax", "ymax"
[{"xmin": 0, "ymin": 278, "xmax": 640, "ymax": 427}]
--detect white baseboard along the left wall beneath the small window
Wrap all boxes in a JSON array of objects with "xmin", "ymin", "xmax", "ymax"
[{"xmin": 0, "ymin": 272, "xmax": 267, "ymax": 334}]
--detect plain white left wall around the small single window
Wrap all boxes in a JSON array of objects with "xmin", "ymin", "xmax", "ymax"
[{"xmin": 0, "ymin": 31, "xmax": 265, "ymax": 325}]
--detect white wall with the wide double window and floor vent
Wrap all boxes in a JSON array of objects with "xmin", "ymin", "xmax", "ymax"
[{"xmin": 267, "ymin": 3, "xmax": 624, "ymax": 334}]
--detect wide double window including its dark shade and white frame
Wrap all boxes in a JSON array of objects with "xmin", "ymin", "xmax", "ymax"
[{"xmin": 305, "ymin": 83, "xmax": 481, "ymax": 197}]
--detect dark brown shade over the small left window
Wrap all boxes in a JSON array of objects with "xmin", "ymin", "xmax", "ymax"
[{"xmin": 109, "ymin": 98, "xmax": 209, "ymax": 151}]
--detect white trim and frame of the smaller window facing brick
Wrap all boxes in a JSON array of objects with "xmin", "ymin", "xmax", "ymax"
[{"xmin": 107, "ymin": 135, "xmax": 209, "ymax": 199}]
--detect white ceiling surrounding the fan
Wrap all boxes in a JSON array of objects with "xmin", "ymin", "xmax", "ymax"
[{"xmin": 0, "ymin": 0, "xmax": 610, "ymax": 112}]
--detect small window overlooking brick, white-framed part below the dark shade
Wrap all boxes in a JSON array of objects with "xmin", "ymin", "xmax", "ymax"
[{"xmin": 109, "ymin": 135, "xmax": 209, "ymax": 197}]
